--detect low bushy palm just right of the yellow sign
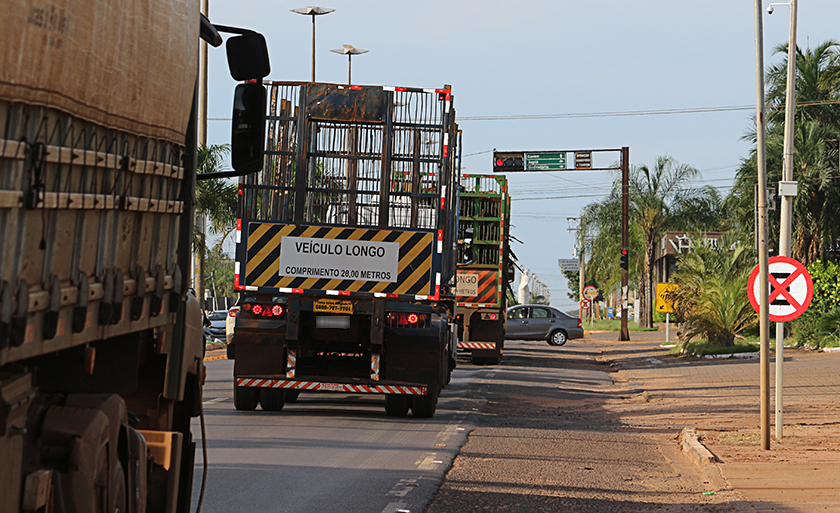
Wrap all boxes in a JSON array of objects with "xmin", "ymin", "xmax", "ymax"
[{"xmin": 672, "ymin": 238, "xmax": 758, "ymax": 347}]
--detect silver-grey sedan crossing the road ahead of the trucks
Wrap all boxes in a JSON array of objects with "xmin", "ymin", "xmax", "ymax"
[{"xmin": 505, "ymin": 305, "xmax": 583, "ymax": 346}]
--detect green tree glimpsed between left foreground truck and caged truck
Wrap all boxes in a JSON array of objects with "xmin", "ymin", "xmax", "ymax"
[{"xmin": 193, "ymin": 144, "xmax": 239, "ymax": 300}]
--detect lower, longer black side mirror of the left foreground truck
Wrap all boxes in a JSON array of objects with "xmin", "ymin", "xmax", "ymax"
[{"xmin": 230, "ymin": 84, "xmax": 266, "ymax": 174}]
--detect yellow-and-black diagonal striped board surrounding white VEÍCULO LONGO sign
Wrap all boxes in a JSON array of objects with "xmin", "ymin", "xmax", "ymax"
[{"xmin": 239, "ymin": 222, "xmax": 435, "ymax": 295}]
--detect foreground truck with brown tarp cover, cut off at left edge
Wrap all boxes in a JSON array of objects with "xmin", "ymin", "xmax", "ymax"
[{"xmin": 0, "ymin": 0, "xmax": 262, "ymax": 513}]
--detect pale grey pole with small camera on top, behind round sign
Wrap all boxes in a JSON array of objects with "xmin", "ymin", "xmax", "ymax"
[{"xmin": 767, "ymin": 0, "xmax": 798, "ymax": 440}]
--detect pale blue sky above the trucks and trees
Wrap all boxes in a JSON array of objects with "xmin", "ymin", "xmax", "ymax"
[{"xmin": 208, "ymin": 0, "xmax": 840, "ymax": 310}]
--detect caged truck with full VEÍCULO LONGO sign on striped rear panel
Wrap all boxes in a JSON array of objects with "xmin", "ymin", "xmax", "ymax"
[{"xmin": 229, "ymin": 82, "xmax": 458, "ymax": 417}]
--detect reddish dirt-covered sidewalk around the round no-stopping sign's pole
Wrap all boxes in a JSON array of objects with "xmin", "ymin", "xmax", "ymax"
[{"xmin": 587, "ymin": 330, "xmax": 840, "ymax": 513}]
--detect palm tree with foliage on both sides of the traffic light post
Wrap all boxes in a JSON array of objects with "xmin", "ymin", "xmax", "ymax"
[{"xmin": 582, "ymin": 156, "xmax": 725, "ymax": 327}]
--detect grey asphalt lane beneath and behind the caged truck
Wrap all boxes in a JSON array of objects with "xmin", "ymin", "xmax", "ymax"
[{"xmin": 193, "ymin": 359, "xmax": 495, "ymax": 513}]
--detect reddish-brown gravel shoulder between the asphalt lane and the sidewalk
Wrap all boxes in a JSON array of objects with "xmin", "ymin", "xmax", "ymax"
[{"xmin": 427, "ymin": 338, "xmax": 735, "ymax": 513}]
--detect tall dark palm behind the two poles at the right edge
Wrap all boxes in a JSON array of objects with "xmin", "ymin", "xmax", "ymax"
[{"xmin": 726, "ymin": 40, "xmax": 840, "ymax": 265}]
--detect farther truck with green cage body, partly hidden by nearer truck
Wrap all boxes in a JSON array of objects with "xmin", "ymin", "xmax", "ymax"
[{"xmin": 455, "ymin": 174, "xmax": 513, "ymax": 365}]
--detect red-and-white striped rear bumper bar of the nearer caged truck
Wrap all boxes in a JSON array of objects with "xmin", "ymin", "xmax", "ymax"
[{"xmin": 236, "ymin": 376, "xmax": 428, "ymax": 395}]
